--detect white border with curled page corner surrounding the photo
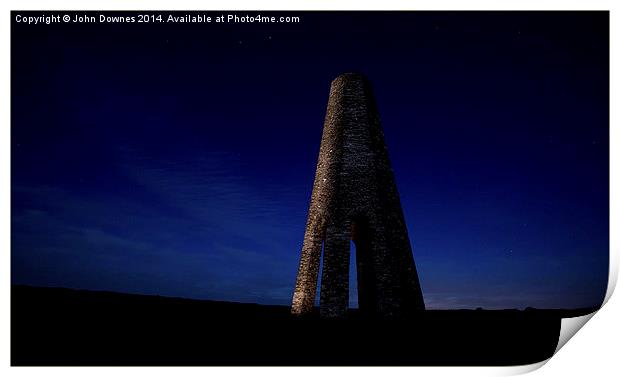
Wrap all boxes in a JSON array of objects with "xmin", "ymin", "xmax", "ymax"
[{"xmin": 0, "ymin": 0, "xmax": 620, "ymax": 377}]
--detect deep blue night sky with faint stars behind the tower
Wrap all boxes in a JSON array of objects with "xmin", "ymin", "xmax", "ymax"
[{"xmin": 11, "ymin": 12, "xmax": 609, "ymax": 309}]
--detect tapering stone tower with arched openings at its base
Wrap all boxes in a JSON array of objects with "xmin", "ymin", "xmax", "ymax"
[{"xmin": 292, "ymin": 73, "xmax": 424, "ymax": 317}]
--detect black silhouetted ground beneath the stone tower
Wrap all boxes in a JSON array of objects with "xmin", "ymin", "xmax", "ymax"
[{"xmin": 11, "ymin": 286, "xmax": 595, "ymax": 366}]
